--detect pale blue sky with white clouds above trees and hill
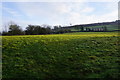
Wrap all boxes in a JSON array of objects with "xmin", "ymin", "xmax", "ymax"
[{"xmin": 2, "ymin": 0, "xmax": 118, "ymax": 29}]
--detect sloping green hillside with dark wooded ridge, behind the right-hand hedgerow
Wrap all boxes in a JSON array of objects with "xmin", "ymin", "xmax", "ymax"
[{"xmin": 62, "ymin": 20, "xmax": 120, "ymax": 31}]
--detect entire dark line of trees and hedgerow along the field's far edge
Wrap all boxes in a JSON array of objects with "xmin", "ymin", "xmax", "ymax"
[{"xmin": 0, "ymin": 23, "xmax": 107, "ymax": 35}]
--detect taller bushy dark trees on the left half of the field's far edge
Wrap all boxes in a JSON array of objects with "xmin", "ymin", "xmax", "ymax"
[{"xmin": 1, "ymin": 24, "xmax": 70, "ymax": 35}]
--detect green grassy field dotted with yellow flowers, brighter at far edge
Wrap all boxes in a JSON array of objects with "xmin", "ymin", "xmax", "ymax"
[{"xmin": 2, "ymin": 32, "xmax": 120, "ymax": 80}]
